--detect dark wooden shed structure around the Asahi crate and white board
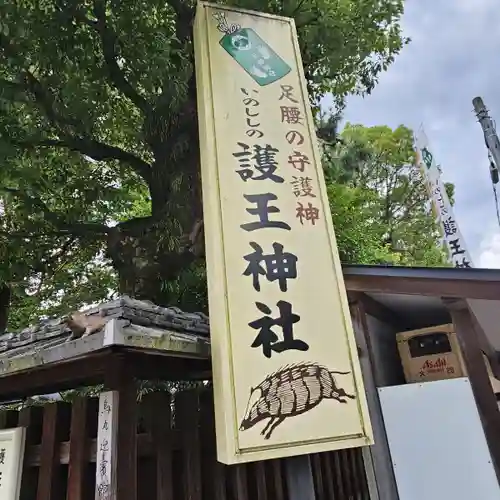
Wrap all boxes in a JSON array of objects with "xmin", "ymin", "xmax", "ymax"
[{"xmin": 344, "ymin": 266, "xmax": 500, "ymax": 500}]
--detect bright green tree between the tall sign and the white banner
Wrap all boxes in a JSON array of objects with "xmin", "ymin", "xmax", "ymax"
[{"xmin": 324, "ymin": 123, "xmax": 453, "ymax": 266}]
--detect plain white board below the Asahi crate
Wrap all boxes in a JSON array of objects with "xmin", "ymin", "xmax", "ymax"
[{"xmin": 378, "ymin": 378, "xmax": 500, "ymax": 500}]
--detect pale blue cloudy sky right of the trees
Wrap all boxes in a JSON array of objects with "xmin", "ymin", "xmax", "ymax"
[{"xmin": 326, "ymin": 0, "xmax": 500, "ymax": 268}]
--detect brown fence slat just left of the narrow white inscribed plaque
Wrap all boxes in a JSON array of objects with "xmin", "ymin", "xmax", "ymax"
[{"xmin": 66, "ymin": 398, "xmax": 88, "ymax": 500}]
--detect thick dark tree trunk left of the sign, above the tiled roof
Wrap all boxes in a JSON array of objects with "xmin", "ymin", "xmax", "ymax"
[{"xmin": 108, "ymin": 109, "xmax": 206, "ymax": 309}]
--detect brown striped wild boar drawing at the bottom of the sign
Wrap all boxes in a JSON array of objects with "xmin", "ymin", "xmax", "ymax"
[{"xmin": 240, "ymin": 362, "xmax": 356, "ymax": 439}]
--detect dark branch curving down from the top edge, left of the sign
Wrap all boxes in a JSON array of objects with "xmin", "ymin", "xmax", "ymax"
[{"xmin": 94, "ymin": 0, "xmax": 151, "ymax": 114}]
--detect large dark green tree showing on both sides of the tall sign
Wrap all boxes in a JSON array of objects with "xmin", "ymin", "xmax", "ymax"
[{"xmin": 0, "ymin": 0, "xmax": 406, "ymax": 328}]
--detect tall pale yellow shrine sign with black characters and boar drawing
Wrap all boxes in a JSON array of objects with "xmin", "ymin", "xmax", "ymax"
[{"xmin": 195, "ymin": 2, "xmax": 372, "ymax": 464}]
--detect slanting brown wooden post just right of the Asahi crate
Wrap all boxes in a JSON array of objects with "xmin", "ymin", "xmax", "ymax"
[{"xmin": 443, "ymin": 298, "xmax": 500, "ymax": 481}]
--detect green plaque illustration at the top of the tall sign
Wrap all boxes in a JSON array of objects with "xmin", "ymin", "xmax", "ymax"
[{"xmin": 220, "ymin": 28, "xmax": 292, "ymax": 86}]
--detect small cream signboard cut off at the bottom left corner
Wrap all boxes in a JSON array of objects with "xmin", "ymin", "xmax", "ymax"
[{"xmin": 0, "ymin": 427, "xmax": 26, "ymax": 500}]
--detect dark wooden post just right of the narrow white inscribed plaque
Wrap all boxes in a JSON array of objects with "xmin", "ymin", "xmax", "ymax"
[{"xmin": 113, "ymin": 381, "xmax": 137, "ymax": 500}]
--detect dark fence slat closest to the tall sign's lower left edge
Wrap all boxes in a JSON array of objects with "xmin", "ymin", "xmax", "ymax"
[{"xmin": 175, "ymin": 390, "xmax": 202, "ymax": 500}]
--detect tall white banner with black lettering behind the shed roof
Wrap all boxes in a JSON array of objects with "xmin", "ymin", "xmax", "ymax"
[{"xmin": 415, "ymin": 128, "xmax": 474, "ymax": 268}]
